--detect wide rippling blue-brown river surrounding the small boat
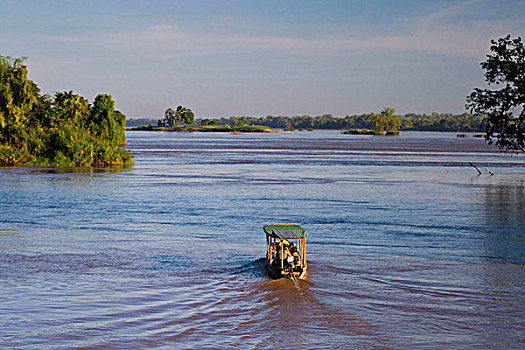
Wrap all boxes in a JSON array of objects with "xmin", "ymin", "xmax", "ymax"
[{"xmin": 0, "ymin": 131, "xmax": 525, "ymax": 349}]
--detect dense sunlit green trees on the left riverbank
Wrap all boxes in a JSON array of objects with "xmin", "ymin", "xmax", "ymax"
[{"xmin": 0, "ymin": 56, "xmax": 132, "ymax": 167}]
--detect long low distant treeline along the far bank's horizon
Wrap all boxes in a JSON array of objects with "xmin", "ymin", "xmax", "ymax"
[{"xmin": 201, "ymin": 113, "xmax": 484, "ymax": 132}]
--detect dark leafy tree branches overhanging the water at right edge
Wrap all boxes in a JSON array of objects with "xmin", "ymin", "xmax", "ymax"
[{"xmin": 466, "ymin": 35, "xmax": 525, "ymax": 152}]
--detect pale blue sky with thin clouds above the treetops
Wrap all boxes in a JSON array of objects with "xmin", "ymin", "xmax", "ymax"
[{"xmin": 0, "ymin": 0, "xmax": 525, "ymax": 119}]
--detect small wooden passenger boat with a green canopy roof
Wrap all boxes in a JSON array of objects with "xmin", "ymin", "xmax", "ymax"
[{"xmin": 263, "ymin": 224, "xmax": 308, "ymax": 280}]
